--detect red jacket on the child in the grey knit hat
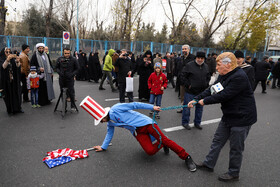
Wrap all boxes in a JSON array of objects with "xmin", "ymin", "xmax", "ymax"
[{"xmin": 148, "ymin": 72, "xmax": 167, "ymax": 95}]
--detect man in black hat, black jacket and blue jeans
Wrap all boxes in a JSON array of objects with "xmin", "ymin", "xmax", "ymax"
[{"xmin": 181, "ymin": 52, "xmax": 211, "ymax": 130}]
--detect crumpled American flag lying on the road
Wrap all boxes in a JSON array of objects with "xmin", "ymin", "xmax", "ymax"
[{"xmin": 43, "ymin": 148, "xmax": 88, "ymax": 168}]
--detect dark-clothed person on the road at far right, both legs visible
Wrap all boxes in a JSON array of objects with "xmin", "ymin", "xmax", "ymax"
[{"xmin": 253, "ymin": 56, "xmax": 271, "ymax": 93}]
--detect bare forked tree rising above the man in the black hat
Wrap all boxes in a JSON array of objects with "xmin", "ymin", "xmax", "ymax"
[{"xmin": 192, "ymin": 0, "xmax": 231, "ymax": 47}]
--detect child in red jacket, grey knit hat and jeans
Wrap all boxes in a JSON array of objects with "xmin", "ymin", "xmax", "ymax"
[{"xmin": 148, "ymin": 62, "xmax": 168, "ymax": 119}]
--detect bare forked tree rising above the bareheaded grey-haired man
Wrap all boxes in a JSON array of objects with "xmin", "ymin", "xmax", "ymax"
[{"xmin": 161, "ymin": 0, "xmax": 195, "ymax": 44}]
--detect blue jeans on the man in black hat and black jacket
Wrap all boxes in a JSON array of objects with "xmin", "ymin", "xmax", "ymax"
[{"xmin": 182, "ymin": 92, "xmax": 203, "ymax": 125}]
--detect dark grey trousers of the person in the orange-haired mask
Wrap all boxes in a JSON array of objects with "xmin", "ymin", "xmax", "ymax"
[{"xmin": 204, "ymin": 121, "xmax": 251, "ymax": 176}]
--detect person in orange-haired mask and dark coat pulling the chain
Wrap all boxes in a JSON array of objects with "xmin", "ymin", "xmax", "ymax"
[{"xmin": 188, "ymin": 52, "xmax": 257, "ymax": 181}]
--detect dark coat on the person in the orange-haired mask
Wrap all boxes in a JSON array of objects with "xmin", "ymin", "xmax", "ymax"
[{"xmin": 194, "ymin": 67, "xmax": 257, "ymax": 127}]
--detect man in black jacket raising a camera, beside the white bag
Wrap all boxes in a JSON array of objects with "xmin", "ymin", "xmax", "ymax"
[{"xmin": 115, "ymin": 49, "xmax": 135, "ymax": 103}]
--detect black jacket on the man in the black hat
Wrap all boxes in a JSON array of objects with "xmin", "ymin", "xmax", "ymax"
[{"xmin": 180, "ymin": 61, "xmax": 211, "ymax": 95}]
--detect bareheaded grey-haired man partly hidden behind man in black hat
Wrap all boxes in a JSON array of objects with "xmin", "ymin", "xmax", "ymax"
[{"xmin": 176, "ymin": 44, "xmax": 195, "ymax": 113}]
